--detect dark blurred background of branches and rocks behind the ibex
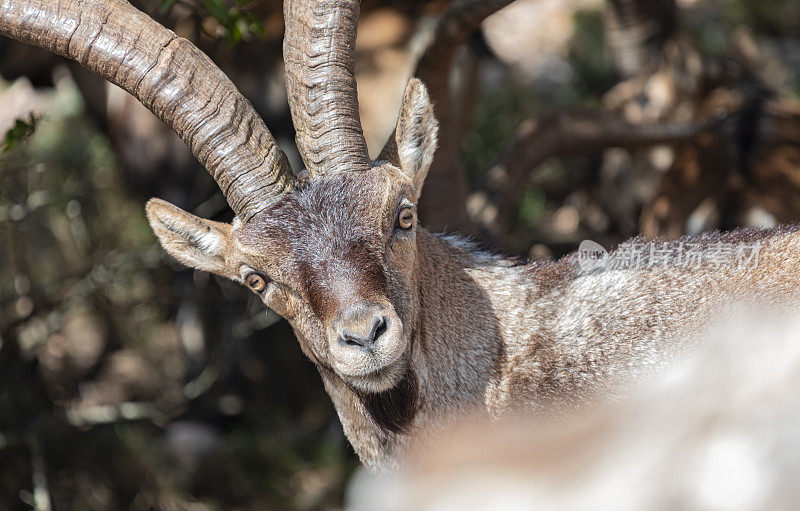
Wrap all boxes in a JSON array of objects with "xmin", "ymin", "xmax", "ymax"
[{"xmin": 0, "ymin": 0, "xmax": 800, "ymax": 511}]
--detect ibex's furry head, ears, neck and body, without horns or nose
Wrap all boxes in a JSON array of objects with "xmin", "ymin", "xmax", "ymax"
[{"xmin": 148, "ymin": 81, "xmax": 800, "ymax": 465}]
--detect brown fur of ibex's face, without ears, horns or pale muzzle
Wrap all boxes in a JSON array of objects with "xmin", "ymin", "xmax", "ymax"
[{"xmin": 232, "ymin": 164, "xmax": 417, "ymax": 390}]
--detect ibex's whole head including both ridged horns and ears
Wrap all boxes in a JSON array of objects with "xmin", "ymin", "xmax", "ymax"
[{"xmin": 0, "ymin": 0, "xmax": 437, "ymax": 404}]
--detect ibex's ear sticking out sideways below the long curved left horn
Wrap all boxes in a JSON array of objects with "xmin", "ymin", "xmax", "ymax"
[{"xmin": 145, "ymin": 199, "xmax": 236, "ymax": 279}]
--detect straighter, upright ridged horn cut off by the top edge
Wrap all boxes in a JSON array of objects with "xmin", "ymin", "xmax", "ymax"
[{"xmin": 283, "ymin": 0, "xmax": 369, "ymax": 178}]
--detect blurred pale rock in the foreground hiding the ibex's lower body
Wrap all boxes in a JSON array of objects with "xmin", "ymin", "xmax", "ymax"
[{"xmin": 345, "ymin": 310, "xmax": 800, "ymax": 511}]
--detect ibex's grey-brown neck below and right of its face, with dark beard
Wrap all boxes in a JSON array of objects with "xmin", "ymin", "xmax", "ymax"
[{"xmin": 321, "ymin": 229, "xmax": 514, "ymax": 466}]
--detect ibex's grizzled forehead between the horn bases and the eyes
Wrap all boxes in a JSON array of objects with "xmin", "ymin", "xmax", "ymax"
[{"xmin": 238, "ymin": 165, "xmax": 409, "ymax": 255}]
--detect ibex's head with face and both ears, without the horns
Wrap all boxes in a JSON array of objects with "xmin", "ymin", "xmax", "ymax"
[{"xmin": 147, "ymin": 79, "xmax": 437, "ymax": 392}]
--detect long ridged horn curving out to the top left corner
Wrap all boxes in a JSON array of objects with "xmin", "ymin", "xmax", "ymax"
[{"xmin": 0, "ymin": 0, "xmax": 294, "ymax": 221}]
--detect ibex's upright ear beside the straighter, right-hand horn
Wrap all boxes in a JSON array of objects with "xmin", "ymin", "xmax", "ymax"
[{"xmin": 378, "ymin": 78, "xmax": 439, "ymax": 198}]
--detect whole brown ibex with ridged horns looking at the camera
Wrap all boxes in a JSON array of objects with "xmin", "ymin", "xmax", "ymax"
[{"xmin": 0, "ymin": 0, "xmax": 800, "ymax": 472}]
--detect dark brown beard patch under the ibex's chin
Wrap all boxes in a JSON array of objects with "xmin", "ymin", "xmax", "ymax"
[{"xmin": 356, "ymin": 367, "xmax": 419, "ymax": 434}]
